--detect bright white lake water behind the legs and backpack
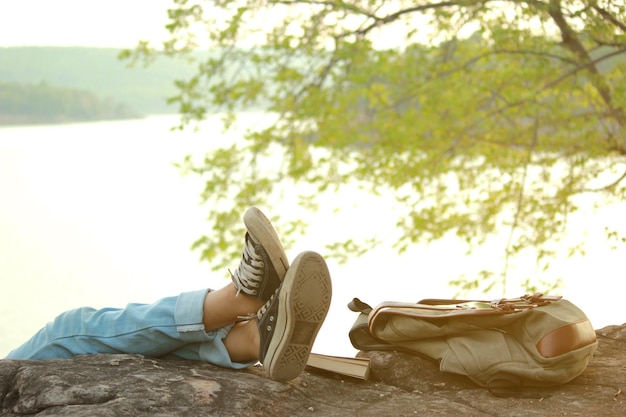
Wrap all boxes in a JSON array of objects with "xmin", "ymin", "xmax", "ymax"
[{"xmin": 0, "ymin": 114, "xmax": 626, "ymax": 358}]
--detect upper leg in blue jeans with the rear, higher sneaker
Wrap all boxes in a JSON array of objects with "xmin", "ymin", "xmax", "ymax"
[{"xmin": 7, "ymin": 207, "xmax": 289, "ymax": 365}]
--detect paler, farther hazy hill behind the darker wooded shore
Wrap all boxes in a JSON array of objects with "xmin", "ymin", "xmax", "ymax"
[{"xmin": 0, "ymin": 47, "xmax": 195, "ymax": 115}]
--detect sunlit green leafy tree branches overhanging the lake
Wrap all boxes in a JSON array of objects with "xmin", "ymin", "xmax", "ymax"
[{"xmin": 124, "ymin": 0, "xmax": 626, "ymax": 292}]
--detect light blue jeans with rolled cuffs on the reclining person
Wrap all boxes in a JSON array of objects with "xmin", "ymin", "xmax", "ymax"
[{"xmin": 6, "ymin": 289, "xmax": 254, "ymax": 369}]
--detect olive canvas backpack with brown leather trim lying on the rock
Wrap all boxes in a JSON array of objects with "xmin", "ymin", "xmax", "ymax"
[{"xmin": 349, "ymin": 294, "xmax": 597, "ymax": 393}]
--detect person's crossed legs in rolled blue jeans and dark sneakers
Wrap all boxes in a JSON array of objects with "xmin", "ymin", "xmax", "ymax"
[{"xmin": 7, "ymin": 209, "xmax": 332, "ymax": 380}]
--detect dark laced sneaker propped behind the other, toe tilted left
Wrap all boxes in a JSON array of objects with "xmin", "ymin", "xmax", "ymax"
[{"xmin": 229, "ymin": 207, "xmax": 289, "ymax": 302}]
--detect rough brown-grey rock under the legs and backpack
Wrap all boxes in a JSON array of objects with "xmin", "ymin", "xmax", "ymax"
[{"xmin": 0, "ymin": 324, "xmax": 626, "ymax": 417}]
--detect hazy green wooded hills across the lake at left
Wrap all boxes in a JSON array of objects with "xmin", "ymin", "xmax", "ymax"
[{"xmin": 0, "ymin": 46, "xmax": 200, "ymax": 125}]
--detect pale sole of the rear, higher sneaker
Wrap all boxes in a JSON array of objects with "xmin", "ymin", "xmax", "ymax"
[{"xmin": 243, "ymin": 207, "xmax": 289, "ymax": 281}]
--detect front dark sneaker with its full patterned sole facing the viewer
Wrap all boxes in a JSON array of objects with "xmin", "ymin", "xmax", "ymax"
[{"xmin": 257, "ymin": 252, "xmax": 332, "ymax": 381}]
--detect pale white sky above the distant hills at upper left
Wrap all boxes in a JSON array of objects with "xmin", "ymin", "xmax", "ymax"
[{"xmin": 0, "ymin": 0, "xmax": 173, "ymax": 48}]
